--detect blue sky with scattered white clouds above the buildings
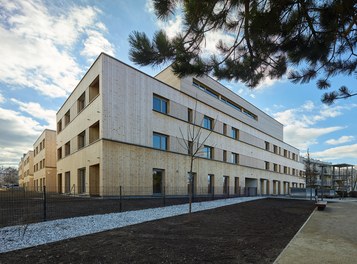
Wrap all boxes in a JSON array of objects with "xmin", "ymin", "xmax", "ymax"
[{"xmin": 0, "ymin": 0, "xmax": 357, "ymax": 167}]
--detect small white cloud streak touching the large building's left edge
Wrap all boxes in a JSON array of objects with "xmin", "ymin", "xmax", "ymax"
[{"xmin": 11, "ymin": 98, "xmax": 56, "ymax": 129}]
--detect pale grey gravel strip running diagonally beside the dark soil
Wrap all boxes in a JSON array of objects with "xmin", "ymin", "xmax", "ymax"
[{"xmin": 0, "ymin": 197, "xmax": 264, "ymax": 253}]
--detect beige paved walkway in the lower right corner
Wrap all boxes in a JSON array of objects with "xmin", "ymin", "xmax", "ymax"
[{"xmin": 274, "ymin": 199, "xmax": 357, "ymax": 264}]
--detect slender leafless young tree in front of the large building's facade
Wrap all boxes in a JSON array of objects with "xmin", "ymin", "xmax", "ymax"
[{"xmin": 178, "ymin": 100, "xmax": 217, "ymax": 213}]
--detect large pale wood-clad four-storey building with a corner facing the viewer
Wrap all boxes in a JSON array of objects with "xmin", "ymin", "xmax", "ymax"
[{"xmin": 56, "ymin": 53, "xmax": 305, "ymax": 196}]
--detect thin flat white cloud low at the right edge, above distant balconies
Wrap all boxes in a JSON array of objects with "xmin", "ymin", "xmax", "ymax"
[{"xmin": 310, "ymin": 144, "xmax": 357, "ymax": 160}]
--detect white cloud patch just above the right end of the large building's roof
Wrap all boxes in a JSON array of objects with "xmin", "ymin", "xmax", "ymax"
[{"xmin": 272, "ymin": 101, "xmax": 351, "ymax": 150}]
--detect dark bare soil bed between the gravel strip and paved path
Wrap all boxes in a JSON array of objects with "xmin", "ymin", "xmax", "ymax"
[{"xmin": 0, "ymin": 199, "xmax": 314, "ymax": 264}]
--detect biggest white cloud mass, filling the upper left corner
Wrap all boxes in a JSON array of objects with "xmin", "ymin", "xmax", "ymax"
[{"xmin": 0, "ymin": 0, "xmax": 114, "ymax": 97}]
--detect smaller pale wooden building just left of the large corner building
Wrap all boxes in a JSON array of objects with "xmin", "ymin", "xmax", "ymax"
[{"xmin": 33, "ymin": 129, "xmax": 57, "ymax": 192}]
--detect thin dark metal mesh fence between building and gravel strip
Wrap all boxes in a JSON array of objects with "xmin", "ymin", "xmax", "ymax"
[{"xmin": 0, "ymin": 186, "xmax": 257, "ymax": 227}]
